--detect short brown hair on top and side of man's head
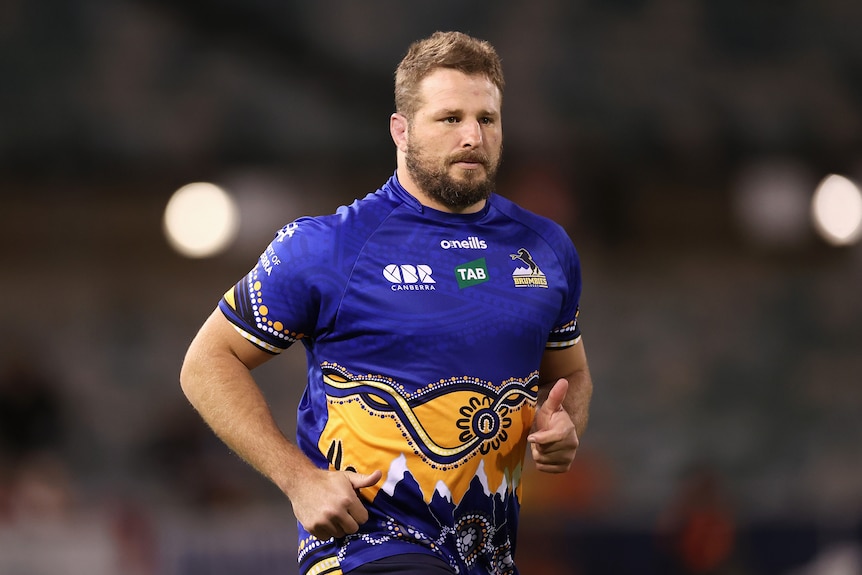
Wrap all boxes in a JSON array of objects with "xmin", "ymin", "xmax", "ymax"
[{"xmin": 395, "ymin": 32, "xmax": 505, "ymax": 119}]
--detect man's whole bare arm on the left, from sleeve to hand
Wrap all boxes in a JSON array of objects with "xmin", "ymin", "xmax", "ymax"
[{"xmin": 180, "ymin": 310, "xmax": 380, "ymax": 539}]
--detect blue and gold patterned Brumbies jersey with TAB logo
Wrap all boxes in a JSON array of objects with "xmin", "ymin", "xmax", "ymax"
[{"xmin": 219, "ymin": 176, "xmax": 581, "ymax": 574}]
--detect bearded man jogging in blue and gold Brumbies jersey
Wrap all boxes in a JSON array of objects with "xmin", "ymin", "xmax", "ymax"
[{"xmin": 181, "ymin": 32, "xmax": 592, "ymax": 574}]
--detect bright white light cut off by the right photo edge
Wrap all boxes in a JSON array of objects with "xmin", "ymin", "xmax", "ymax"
[{"xmin": 811, "ymin": 174, "xmax": 862, "ymax": 246}]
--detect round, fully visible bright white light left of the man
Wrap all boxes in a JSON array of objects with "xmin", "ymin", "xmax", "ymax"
[{"xmin": 163, "ymin": 182, "xmax": 239, "ymax": 258}]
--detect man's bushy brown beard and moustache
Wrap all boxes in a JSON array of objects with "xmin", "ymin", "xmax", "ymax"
[{"xmin": 405, "ymin": 141, "xmax": 501, "ymax": 212}]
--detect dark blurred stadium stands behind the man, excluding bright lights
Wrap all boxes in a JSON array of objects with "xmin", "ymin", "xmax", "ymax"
[{"xmin": 0, "ymin": 0, "xmax": 862, "ymax": 575}]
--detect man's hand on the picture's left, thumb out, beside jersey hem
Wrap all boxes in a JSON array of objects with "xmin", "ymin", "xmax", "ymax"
[{"xmin": 289, "ymin": 469, "xmax": 383, "ymax": 539}]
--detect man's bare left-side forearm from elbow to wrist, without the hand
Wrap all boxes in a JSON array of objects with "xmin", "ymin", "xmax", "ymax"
[{"xmin": 180, "ymin": 343, "xmax": 314, "ymax": 496}]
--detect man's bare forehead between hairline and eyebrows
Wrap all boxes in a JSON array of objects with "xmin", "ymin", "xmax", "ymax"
[{"xmin": 419, "ymin": 68, "xmax": 501, "ymax": 113}]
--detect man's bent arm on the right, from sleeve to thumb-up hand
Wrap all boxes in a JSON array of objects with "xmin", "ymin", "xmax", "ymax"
[{"xmin": 528, "ymin": 339, "xmax": 593, "ymax": 473}]
